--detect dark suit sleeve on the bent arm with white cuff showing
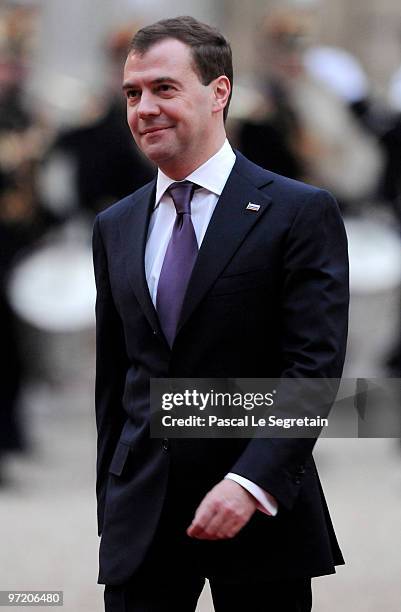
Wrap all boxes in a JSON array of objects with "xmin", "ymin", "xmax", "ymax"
[{"xmin": 231, "ymin": 190, "xmax": 349, "ymax": 510}]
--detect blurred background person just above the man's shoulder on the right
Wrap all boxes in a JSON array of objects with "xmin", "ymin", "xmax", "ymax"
[{"xmin": 233, "ymin": 9, "xmax": 307, "ymax": 179}]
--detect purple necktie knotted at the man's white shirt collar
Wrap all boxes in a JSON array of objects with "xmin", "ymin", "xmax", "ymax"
[{"xmin": 156, "ymin": 181, "xmax": 198, "ymax": 346}]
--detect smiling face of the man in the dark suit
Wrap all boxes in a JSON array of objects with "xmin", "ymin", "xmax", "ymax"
[{"xmin": 123, "ymin": 38, "xmax": 222, "ymax": 178}]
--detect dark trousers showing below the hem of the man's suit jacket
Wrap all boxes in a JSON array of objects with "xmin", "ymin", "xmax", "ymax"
[{"xmin": 104, "ymin": 577, "xmax": 312, "ymax": 612}]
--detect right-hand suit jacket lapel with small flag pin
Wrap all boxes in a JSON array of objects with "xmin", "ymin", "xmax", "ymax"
[{"xmin": 177, "ymin": 154, "xmax": 273, "ymax": 333}]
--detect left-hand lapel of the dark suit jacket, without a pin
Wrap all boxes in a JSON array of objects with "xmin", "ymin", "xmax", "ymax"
[{"xmin": 120, "ymin": 180, "xmax": 165, "ymax": 340}]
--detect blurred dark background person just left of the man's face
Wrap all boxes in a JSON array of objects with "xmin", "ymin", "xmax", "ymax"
[{"xmin": 41, "ymin": 24, "xmax": 154, "ymax": 219}]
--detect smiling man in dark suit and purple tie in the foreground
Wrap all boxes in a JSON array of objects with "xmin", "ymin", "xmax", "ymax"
[{"xmin": 94, "ymin": 17, "xmax": 348, "ymax": 612}]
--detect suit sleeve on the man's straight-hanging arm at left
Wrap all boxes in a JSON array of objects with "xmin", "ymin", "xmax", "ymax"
[{"xmin": 93, "ymin": 217, "xmax": 128, "ymax": 535}]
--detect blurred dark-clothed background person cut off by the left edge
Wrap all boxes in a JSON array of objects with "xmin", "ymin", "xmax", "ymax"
[{"xmin": 0, "ymin": 2, "xmax": 52, "ymax": 486}]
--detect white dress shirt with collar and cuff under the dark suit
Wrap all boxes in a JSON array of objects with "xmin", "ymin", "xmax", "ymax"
[{"xmin": 145, "ymin": 139, "xmax": 277, "ymax": 516}]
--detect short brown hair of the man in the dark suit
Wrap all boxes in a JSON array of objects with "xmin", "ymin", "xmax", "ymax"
[{"xmin": 128, "ymin": 16, "xmax": 233, "ymax": 120}]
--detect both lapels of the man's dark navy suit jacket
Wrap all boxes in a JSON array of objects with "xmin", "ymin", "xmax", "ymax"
[{"xmin": 114, "ymin": 153, "xmax": 273, "ymax": 346}]
